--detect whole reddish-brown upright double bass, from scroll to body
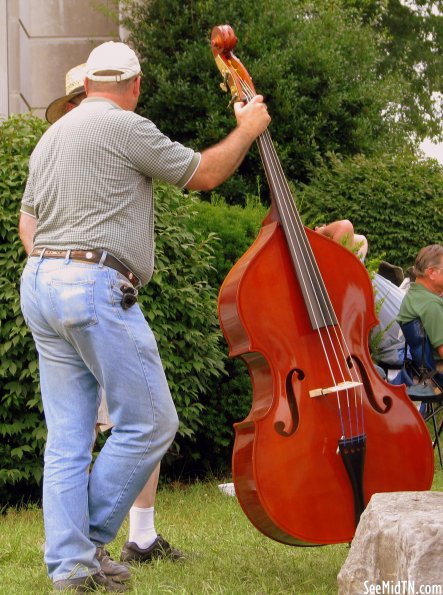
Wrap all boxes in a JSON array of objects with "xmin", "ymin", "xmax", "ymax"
[{"xmin": 211, "ymin": 25, "xmax": 434, "ymax": 545}]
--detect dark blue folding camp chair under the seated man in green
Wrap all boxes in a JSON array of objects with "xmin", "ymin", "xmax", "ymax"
[{"xmin": 400, "ymin": 318, "xmax": 443, "ymax": 469}]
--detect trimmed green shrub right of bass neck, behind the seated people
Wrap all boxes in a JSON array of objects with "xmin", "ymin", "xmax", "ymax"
[{"xmin": 296, "ymin": 153, "xmax": 443, "ymax": 268}]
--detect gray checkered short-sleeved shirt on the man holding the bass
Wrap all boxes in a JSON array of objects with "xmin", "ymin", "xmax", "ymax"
[{"xmin": 21, "ymin": 98, "xmax": 200, "ymax": 283}]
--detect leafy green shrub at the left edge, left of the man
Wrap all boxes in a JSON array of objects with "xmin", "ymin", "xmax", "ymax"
[{"xmin": 0, "ymin": 116, "xmax": 46, "ymax": 501}]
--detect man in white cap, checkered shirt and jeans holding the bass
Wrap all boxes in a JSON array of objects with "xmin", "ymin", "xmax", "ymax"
[{"xmin": 19, "ymin": 42, "xmax": 270, "ymax": 592}]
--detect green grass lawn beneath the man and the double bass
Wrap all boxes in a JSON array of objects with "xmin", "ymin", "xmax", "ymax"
[{"xmin": 0, "ymin": 465, "xmax": 443, "ymax": 595}]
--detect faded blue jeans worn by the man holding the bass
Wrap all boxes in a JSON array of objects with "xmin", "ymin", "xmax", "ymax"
[{"xmin": 21, "ymin": 257, "xmax": 178, "ymax": 580}]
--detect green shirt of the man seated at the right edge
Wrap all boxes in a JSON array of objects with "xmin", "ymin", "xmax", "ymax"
[{"xmin": 397, "ymin": 283, "xmax": 443, "ymax": 349}]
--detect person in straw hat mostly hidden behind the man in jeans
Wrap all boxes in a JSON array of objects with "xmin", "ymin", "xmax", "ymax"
[{"xmin": 45, "ymin": 64, "xmax": 180, "ymax": 566}]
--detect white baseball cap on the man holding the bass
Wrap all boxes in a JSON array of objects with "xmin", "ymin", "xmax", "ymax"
[{"xmin": 86, "ymin": 41, "xmax": 141, "ymax": 83}]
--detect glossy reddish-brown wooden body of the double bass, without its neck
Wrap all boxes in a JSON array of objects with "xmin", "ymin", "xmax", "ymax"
[{"xmin": 219, "ymin": 222, "xmax": 434, "ymax": 545}]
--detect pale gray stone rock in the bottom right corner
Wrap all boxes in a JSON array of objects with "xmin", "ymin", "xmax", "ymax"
[{"xmin": 337, "ymin": 492, "xmax": 443, "ymax": 595}]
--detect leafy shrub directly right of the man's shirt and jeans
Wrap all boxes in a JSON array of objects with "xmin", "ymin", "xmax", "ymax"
[{"xmin": 139, "ymin": 184, "xmax": 226, "ymax": 462}]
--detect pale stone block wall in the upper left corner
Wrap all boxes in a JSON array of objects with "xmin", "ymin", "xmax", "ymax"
[{"xmin": 0, "ymin": 0, "xmax": 119, "ymax": 117}]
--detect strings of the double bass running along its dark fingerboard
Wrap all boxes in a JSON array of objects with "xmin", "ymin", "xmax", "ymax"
[{"xmin": 242, "ymin": 80, "xmax": 364, "ymax": 437}]
